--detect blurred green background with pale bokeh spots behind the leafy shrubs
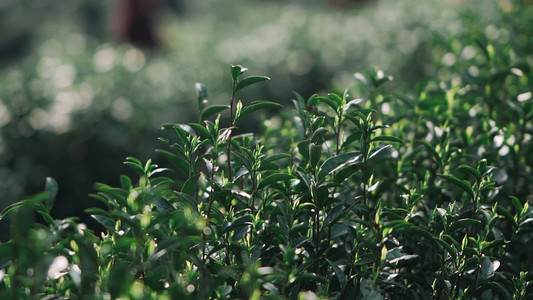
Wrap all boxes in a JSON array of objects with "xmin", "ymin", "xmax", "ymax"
[{"xmin": 0, "ymin": 0, "xmax": 533, "ymax": 238}]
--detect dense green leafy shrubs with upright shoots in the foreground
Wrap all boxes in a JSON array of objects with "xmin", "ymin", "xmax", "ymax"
[{"xmin": 0, "ymin": 1, "xmax": 533, "ymax": 299}]
